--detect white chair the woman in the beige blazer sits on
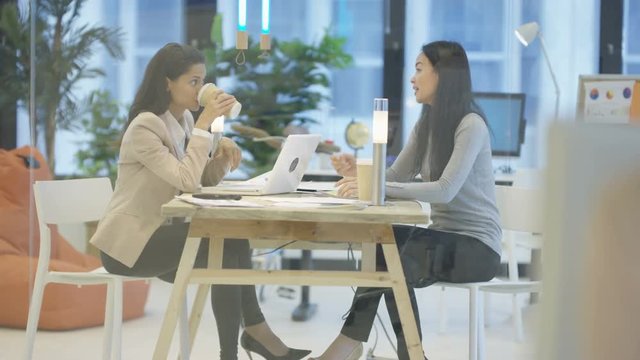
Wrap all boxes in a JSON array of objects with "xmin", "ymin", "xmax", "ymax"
[{"xmin": 24, "ymin": 178, "xmax": 188, "ymax": 360}]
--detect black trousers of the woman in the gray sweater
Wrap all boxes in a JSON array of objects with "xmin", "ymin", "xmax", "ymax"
[{"xmin": 341, "ymin": 225, "xmax": 500, "ymax": 360}]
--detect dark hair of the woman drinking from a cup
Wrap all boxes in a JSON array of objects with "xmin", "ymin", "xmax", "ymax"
[{"xmin": 125, "ymin": 43, "xmax": 204, "ymax": 130}]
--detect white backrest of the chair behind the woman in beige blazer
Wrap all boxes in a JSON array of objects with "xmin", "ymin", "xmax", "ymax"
[{"xmin": 33, "ymin": 178, "xmax": 113, "ymax": 224}]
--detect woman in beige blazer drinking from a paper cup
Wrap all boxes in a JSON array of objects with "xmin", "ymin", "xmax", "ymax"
[{"xmin": 91, "ymin": 43, "xmax": 309, "ymax": 360}]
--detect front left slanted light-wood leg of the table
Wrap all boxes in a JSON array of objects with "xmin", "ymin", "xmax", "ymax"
[{"xmin": 153, "ymin": 237, "xmax": 201, "ymax": 360}]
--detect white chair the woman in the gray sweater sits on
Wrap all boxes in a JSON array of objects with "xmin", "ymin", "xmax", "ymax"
[{"xmin": 437, "ymin": 186, "xmax": 544, "ymax": 360}]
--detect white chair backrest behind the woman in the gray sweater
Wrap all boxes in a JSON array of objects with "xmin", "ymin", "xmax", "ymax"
[{"xmin": 496, "ymin": 185, "xmax": 544, "ymax": 233}]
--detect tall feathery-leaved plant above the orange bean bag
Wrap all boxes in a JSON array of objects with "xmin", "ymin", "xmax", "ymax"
[{"xmin": 0, "ymin": 0, "xmax": 123, "ymax": 171}]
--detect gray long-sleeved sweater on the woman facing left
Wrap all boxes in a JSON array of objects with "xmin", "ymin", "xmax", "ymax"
[{"xmin": 385, "ymin": 113, "xmax": 502, "ymax": 254}]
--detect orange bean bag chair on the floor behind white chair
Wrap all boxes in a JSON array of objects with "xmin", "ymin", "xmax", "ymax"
[{"xmin": 0, "ymin": 147, "xmax": 149, "ymax": 330}]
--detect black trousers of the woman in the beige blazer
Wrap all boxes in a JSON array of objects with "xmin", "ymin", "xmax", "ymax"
[{"xmin": 101, "ymin": 223, "xmax": 265, "ymax": 359}]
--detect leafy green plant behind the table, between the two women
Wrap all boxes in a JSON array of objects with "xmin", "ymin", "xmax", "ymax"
[{"xmin": 204, "ymin": 15, "xmax": 352, "ymax": 175}]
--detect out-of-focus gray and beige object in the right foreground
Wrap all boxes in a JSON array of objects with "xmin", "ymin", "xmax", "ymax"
[{"xmin": 537, "ymin": 123, "xmax": 640, "ymax": 360}]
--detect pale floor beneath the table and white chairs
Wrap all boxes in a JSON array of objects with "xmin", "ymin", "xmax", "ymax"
[{"xmin": 0, "ymin": 281, "xmax": 538, "ymax": 360}]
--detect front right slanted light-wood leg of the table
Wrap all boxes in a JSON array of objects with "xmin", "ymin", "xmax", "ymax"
[{"xmin": 382, "ymin": 244, "xmax": 424, "ymax": 360}]
